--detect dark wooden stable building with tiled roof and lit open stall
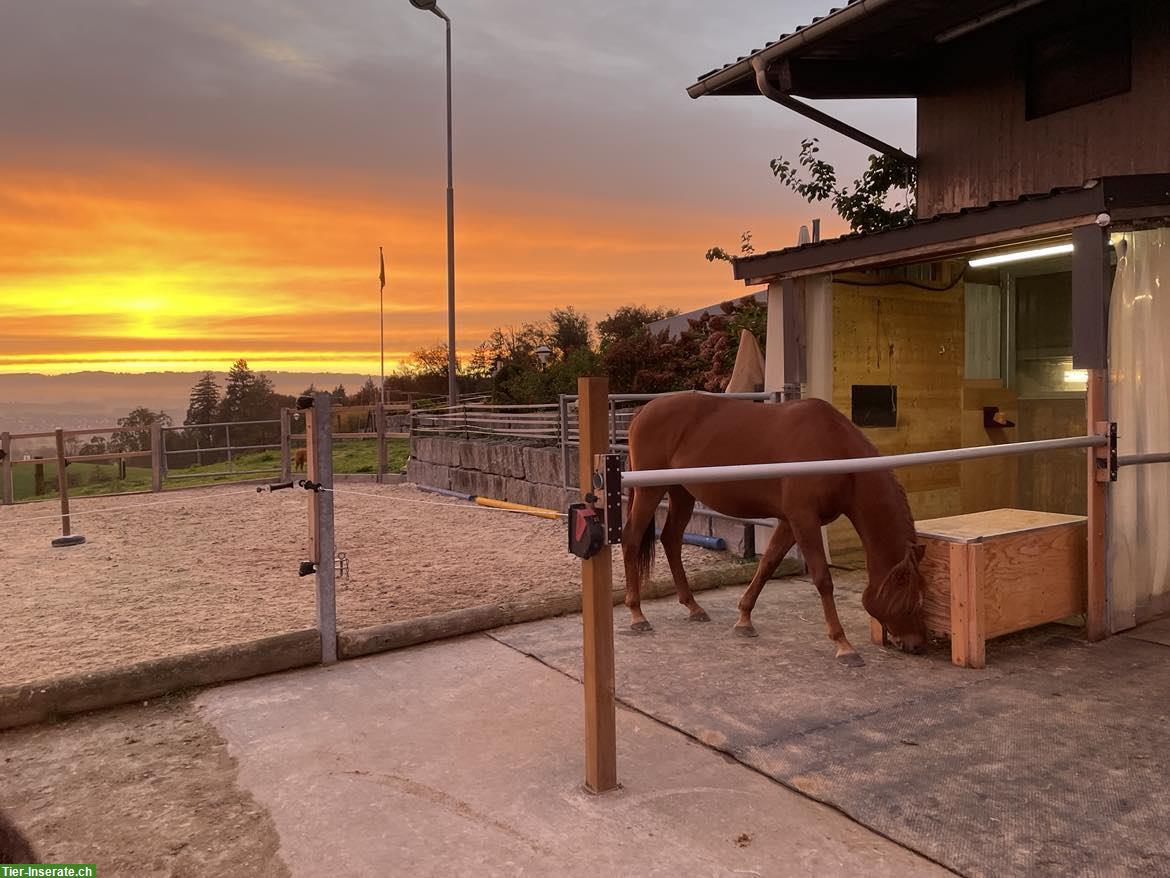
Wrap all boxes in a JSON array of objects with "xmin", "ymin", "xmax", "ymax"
[{"xmin": 688, "ymin": 0, "xmax": 1170, "ymax": 636}]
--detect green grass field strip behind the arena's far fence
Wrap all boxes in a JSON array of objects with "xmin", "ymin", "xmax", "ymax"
[{"xmin": 12, "ymin": 439, "xmax": 411, "ymax": 502}]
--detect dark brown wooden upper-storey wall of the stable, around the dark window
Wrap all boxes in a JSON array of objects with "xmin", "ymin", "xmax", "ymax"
[{"xmin": 917, "ymin": 0, "xmax": 1170, "ymax": 217}]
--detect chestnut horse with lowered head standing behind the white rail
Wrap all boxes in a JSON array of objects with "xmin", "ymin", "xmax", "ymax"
[{"xmin": 621, "ymin": 393, "xmax": 927, "ymax": 665}]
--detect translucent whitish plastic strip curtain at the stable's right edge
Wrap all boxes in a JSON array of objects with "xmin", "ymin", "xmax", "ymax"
[{"xmin": 1108, "ymin": 228, "xmax": 1170, "ymax": 631}]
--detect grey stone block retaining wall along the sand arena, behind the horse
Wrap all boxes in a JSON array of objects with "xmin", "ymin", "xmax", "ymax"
[{"xmin": 406, "ymin": 435, "xmax": 764, "ymax": 557}]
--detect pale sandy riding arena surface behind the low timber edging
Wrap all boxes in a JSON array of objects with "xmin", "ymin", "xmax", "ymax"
[{"xmin": 0, "ymin": 482, "xmax": 730, "ymax": 685}]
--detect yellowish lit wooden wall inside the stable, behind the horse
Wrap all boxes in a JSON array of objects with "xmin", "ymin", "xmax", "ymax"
[{"xmin": 828, "ymin": 276, "xmax": 963, "ymax": 560}]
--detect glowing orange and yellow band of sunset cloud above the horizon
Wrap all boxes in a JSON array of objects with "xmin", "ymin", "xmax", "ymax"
[{"xmin": 0, "ymin": 165, "xmax": 782, "ymax": 372}]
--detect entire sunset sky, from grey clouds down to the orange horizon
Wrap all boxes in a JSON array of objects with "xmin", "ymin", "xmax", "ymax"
[{"xmin": 0, "ymin": 0, "xmax": 914, "ymax": 373}]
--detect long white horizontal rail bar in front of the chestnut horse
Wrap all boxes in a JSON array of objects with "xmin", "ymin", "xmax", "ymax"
[{"xmin": 621, "ymin": 435, "xmax": 1109, "ymax": 488}]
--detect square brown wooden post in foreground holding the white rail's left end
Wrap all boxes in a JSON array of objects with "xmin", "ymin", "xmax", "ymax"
[{"xmin": 577, "ymin": 378, "xmax": 618, "ymax": 793}]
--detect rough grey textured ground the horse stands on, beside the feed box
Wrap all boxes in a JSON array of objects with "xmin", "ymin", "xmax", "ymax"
[{"xmin": 494, "ymin": 572, "xmax": 1170, "ymax": 876}]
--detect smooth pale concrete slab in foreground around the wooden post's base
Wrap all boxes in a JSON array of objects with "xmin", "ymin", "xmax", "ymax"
[{"xmin": 197, "ymin": 636, "xmax": 944, "ymax": 878}]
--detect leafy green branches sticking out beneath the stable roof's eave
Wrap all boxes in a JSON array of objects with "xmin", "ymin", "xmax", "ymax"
[{"xmin": 772, "ymin": 137, "xmax": 917, "ymax": 235}]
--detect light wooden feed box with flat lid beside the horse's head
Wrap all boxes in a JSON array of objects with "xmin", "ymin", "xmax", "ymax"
[{"xmin": 878, "ymin": 509, "xmax": 1088, "ymax": 667}]
